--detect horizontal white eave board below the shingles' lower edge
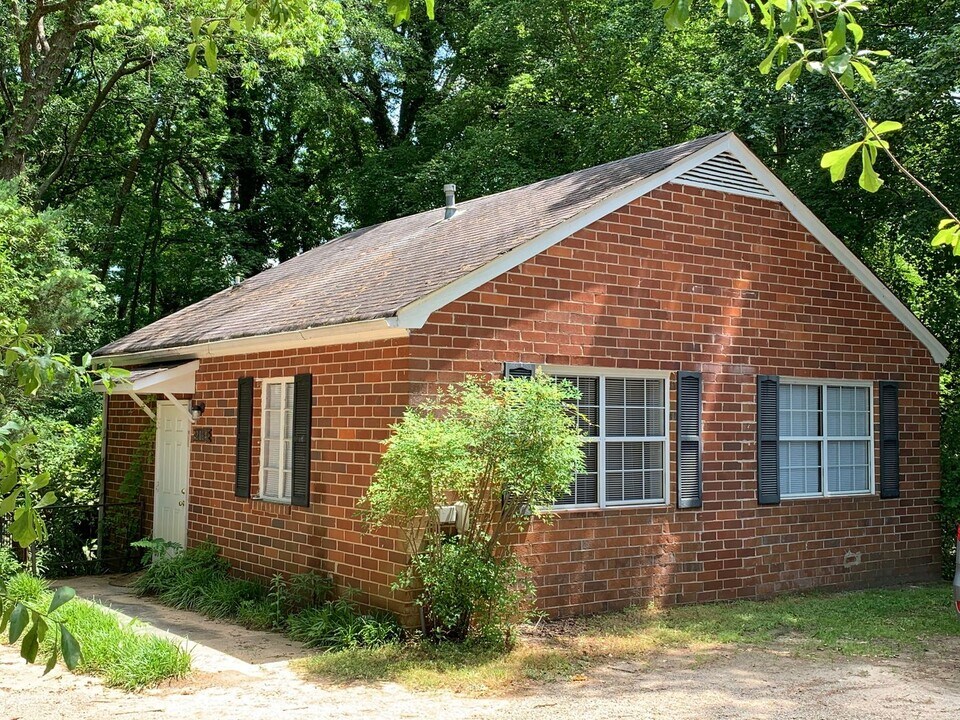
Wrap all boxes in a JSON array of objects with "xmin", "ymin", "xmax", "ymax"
[{"xmin": 94, "ymin": 318, "xmax": 410, "ymax": 367}]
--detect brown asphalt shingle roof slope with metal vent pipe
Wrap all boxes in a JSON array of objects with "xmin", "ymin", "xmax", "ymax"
[{"xmin": 95, "ymin": 135, "xmax": 722, "ymax": 356}]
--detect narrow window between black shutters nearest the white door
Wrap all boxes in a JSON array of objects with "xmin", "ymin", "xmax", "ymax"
[{"xmin": 260, "ymin": 379, "xmax": 293, "ymax": 502}]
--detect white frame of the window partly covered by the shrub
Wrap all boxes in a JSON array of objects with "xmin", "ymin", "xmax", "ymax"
[{"xmin": 540, "ymin": 365, "xmax": 673, "ymax": 512}]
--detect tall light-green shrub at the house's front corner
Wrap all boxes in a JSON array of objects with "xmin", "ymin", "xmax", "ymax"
[{"xmin": 360, "ymin": 373, "xmax": 584, "ymax": 644}]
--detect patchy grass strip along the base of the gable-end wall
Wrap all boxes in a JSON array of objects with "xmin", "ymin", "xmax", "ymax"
[{"xmin": 300, "ymin": 585, "xmax": 960, "ymax": 695}]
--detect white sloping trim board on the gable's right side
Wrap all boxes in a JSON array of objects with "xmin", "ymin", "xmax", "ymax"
[{"xmin": 723, "ymin": 135, "xmax": 950, "ymax": 365}]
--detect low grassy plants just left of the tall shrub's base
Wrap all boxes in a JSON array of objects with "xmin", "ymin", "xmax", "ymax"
[{"xmin": 287, "ymin": 599, "xmax": 403, "ymax": 650}]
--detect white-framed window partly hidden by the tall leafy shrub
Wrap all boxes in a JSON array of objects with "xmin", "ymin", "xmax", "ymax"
[{"xmin": 553, "ymin": 372, "xmax": 668, "ymax": 508}]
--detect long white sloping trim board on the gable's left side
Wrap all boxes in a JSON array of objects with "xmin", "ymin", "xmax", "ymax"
[{"xmin": 397, "ymin": 138, "xmax": 727, "ymax": 329}]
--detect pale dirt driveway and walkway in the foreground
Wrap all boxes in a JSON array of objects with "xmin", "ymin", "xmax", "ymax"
[{"xmin": 0, "ymin": 581, "xmax": 960, "ymax": 720}]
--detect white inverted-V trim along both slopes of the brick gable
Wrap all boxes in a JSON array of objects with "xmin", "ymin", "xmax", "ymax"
[{"xmin": 397, "ymin": 133, "xmax": 949, "ymax": 365}]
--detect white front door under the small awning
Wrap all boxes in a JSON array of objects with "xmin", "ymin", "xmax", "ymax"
[{"xmin": 153, "ymin": 401, "xmax": 190, "ymax": 546}]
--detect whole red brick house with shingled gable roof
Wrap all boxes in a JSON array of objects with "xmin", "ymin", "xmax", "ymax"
[{"xmin": 97, "ymin": 134, "xmax": 947, "ymax": 615}]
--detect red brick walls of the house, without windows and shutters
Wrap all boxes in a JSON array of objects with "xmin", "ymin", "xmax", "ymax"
[{"xmin": 108, "ymin": 179, "xmax": 939, "ymax": 614}]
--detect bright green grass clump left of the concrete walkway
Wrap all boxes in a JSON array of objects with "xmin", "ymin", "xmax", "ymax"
[{"xmin": 7, "ymin": 573, "xmax": 190, "ymax": 690}]
